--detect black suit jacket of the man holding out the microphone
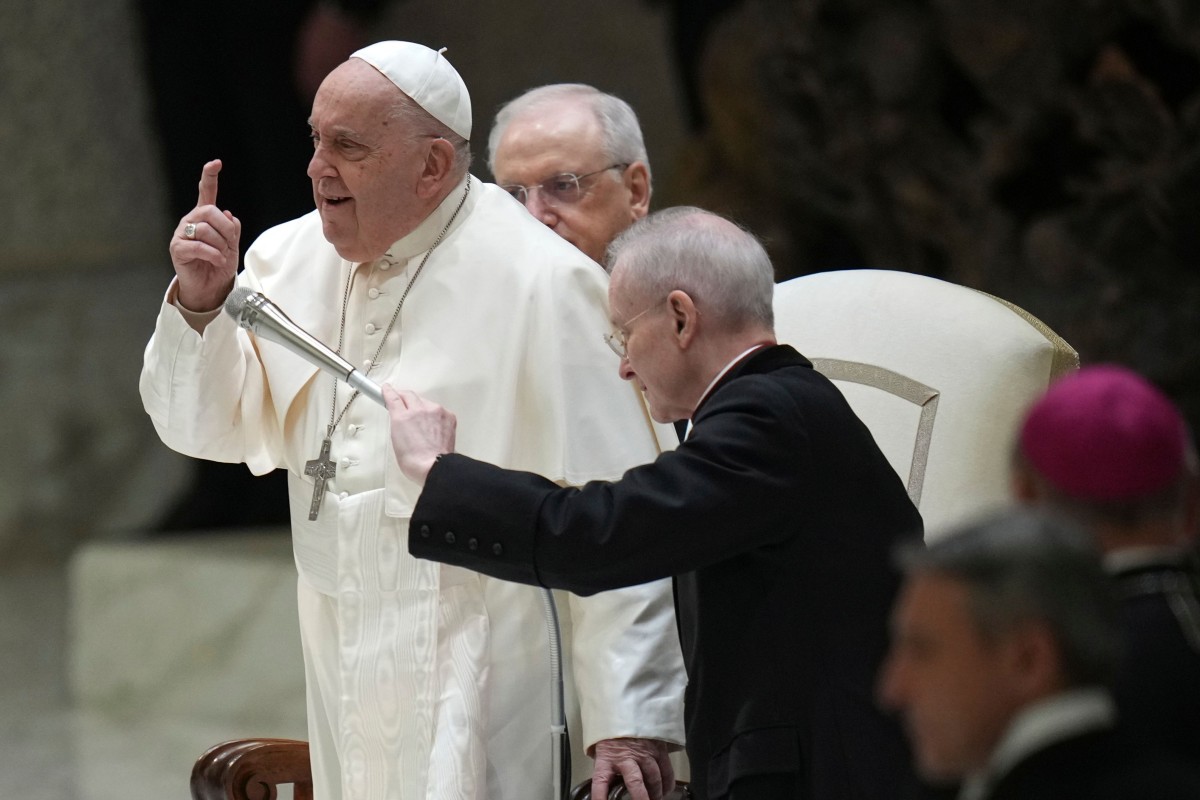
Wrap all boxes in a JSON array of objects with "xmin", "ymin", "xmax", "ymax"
[{"xmin": 409, "ymin": 345, "xmax": 922, "ymax": 800}]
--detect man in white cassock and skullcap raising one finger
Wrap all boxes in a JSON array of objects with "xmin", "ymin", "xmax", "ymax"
[{"xmin": 142, "ymin": 42, "xmax": 683, "ymax": 800}]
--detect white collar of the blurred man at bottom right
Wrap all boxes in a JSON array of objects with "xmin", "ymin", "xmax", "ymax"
[{"xmin": 959, "ymin": 687, "xmax": 1116, "ymax": 800}]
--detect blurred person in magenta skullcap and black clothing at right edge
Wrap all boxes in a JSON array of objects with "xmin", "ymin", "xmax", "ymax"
[{"xmin": 1013, "ymin": 365, "xmax": 1200, "ymax": 769}]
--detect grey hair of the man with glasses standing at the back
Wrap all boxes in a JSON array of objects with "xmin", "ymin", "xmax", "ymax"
[{"xmin": 487, "ymin": 83, "xmax": 650, "ymax": 175}]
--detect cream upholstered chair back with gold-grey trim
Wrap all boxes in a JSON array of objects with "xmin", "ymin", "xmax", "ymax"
[{"xmin": 775, "ymin": 270, "xmax": 1079, "ymax": 540}]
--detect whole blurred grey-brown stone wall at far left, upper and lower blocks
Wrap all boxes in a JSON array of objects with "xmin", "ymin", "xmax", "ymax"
[{"xmin": 0, "ymin": 0, "xmax": 187, "ymax": 561}]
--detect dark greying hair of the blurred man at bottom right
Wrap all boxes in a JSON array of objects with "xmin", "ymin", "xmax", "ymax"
[{"xmin": 898, "ymin": 509, "xmax": 1121, "ymax": 686}]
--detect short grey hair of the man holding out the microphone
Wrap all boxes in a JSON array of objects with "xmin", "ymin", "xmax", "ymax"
[{"xmin": 605, "ymin": 206, "xmax": 775, "ymax": 331}]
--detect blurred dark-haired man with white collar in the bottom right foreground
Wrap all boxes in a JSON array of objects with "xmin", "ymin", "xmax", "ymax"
[{"xmin": 878, "ymin": 511, "xmax": 1200, "ymax": 800}]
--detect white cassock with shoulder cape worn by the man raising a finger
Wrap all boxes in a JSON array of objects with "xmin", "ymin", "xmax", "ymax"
[{"xmin": 142, "ymin": 179, "xmax": 684, "ymax": 800}]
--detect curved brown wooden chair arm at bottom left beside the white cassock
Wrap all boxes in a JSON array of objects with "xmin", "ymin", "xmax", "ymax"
[{"xmin": 192, "ymin": 739, "xmax": 312, "ymax": 800}]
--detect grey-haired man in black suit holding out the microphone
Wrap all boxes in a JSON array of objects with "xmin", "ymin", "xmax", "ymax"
[{"xmin": 385, "ymin": 207, "xmax": 922, "ymax": 800}]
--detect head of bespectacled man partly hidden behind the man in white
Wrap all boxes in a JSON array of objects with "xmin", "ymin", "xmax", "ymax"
[{"xmin": 487, "ymin": 84, "xmax": 652, "ymax": 264}]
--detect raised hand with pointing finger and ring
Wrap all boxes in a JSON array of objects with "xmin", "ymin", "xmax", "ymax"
[{"xmin": 170, "ymin": 160, "xmax": 241, "ymax": 311}]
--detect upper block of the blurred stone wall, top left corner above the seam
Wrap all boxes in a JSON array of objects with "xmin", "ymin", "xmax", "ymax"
[{"xmin": 0, "ymin": 0, "xmax": 163, "ymax": 272}]
